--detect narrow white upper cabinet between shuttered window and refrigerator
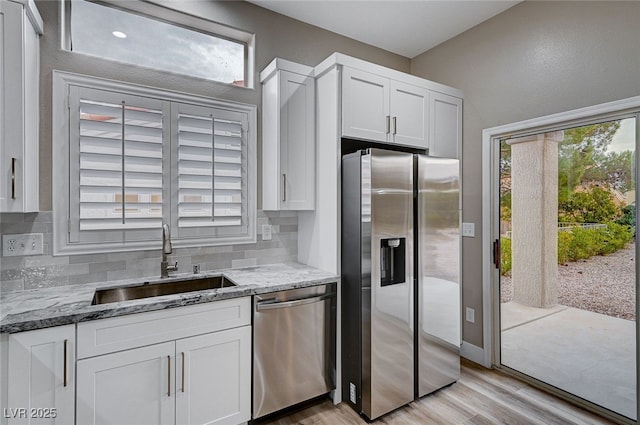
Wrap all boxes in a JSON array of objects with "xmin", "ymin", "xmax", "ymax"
[{"xmin": 260, "ymin": 59, "xmax": 315, "ymax": 211}]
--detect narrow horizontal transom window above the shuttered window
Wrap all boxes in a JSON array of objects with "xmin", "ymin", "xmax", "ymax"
[{"xmin": 63, "ymin": 0, "xmax": 253, "ymax": 87}]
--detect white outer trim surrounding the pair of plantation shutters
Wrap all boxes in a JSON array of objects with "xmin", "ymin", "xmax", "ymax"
[{"xmin": 52, "ymin": 70, "xmax": 257, "ymax": 255}]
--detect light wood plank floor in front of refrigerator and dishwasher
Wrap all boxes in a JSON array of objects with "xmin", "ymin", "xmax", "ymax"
[{"xmin": 260, "ymin": 359, "xmax": 614, "ymax": 425}]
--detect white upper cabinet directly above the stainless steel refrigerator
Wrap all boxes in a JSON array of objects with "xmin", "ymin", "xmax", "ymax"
[{"xmin": 328, "ymin": 53, "xmax": 462, "ymax": 158}]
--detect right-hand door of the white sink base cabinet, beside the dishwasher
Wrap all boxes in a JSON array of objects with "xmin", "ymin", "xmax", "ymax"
[{"xmin": 176, "ymin": 326, "xmax": 251, "ymax": 425}]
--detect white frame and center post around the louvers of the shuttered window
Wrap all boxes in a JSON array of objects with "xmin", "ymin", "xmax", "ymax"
[{"xmin": 52, "ymin": 70, "xmax": 257, "ymax": 255}]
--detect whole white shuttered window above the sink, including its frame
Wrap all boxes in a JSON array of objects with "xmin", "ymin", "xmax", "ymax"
[{"xmin": 53, "ymin": 71, "xmax": 256, "ymax": 254}]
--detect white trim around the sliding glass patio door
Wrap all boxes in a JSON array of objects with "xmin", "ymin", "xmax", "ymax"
[{"xmin": 478, "ymin": 96, "xmax": 640, "ymax": 367}]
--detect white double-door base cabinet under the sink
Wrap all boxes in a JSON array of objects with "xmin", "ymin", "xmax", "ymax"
[{"xmin": 76, "ymin": 298, "xmax": 251, "ymax": 425}]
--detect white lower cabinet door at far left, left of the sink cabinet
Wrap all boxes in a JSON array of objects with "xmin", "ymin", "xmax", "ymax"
[{"xmin": 3, "ymin": 325, "xmax": 75, "ymax": 425}]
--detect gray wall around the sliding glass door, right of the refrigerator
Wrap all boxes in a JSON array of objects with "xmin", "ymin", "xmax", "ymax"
[{"xmin": 411, "ymin": 1, "xmax": 640, "ymax": 347}]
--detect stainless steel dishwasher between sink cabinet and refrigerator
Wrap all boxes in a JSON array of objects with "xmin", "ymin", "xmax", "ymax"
[{"xmin": 253, "ymin": 283, "xmax": 336, "ymax": 419}]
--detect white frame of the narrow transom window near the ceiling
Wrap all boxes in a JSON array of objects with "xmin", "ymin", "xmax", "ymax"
[{"xmin": 60, "ymin": 0, "xmax": 256, "ymax": 90}]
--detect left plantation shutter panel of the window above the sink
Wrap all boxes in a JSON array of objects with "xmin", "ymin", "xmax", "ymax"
[{"xmin": 69, "ymin": 87, "xmax": 165, "ymax": 242}]
